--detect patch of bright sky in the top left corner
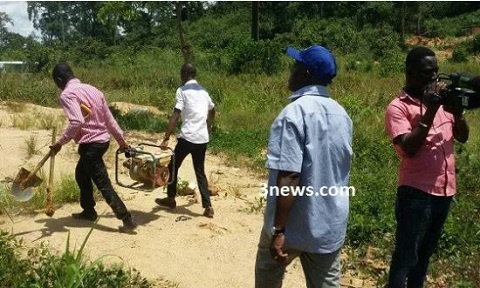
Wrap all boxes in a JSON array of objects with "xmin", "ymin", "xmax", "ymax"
[{"xmin": 0, "ymin": 1, "xmax": 40, "ymax": 36}]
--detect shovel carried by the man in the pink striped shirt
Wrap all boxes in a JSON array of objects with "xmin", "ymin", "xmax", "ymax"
[{"xmin": 11, "ymin": 150, "xmax": 54, "ymax": 202}]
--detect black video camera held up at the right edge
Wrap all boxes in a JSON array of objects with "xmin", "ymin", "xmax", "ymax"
[{"xmin": 429, "ymin": 73, "xmax": 480, "ymax": 110}]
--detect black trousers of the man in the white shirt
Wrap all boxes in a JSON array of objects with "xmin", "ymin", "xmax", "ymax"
[{"xmin": 167, "ymin": 138, "xmax": 212, "ymax": 208}]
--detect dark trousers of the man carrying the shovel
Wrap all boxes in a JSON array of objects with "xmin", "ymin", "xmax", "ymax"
[{"xmin": 75, "ymin": 142, "xmax": 131, "ymax": 220}]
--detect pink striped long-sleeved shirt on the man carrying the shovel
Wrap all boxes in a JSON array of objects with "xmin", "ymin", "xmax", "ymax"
[{"xmin": 58, "ymin": 78, "xmax": 126, "ymax": 146}]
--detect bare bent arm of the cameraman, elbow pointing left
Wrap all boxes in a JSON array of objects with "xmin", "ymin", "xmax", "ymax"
[{"xmin": 393, "ymin": 104, "xmax": 440, "ymax": 157}]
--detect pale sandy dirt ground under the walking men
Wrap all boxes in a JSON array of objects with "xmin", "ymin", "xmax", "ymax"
[{"xmin": 0, "ymin": 103, "xmax": 372, "ymax": 288}]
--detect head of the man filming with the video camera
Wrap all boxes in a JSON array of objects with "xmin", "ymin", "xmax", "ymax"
[{"xmin": 405, "ymin": 47, "xmax": 438, "ymax": 93}]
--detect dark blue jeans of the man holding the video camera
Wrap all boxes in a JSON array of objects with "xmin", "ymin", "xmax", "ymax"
[{"xmin": 388, "ymin": 186, "xmax": 452, "ymax": 288}]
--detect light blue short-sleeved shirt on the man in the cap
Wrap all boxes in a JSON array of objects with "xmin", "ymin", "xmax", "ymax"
[{"xmin": 264, "ymin": 85, "xmax": 353, "ymax": 253}]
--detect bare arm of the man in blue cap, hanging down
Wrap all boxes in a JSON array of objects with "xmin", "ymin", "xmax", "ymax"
[{"xmin": 270, "ymin": 171, "xmax": 300, "ymax": 263}]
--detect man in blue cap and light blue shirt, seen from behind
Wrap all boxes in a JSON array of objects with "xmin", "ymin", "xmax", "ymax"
[{"xmin": 255, "ymin": 45, "xmax": 352, "ymax": 288}]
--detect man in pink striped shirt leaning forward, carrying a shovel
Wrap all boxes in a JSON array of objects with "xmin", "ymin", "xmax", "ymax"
[{"xmin": 50, "ymin": 64, "xmax": 137, "ymax": 231}]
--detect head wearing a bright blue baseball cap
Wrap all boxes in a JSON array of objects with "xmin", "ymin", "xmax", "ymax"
[{"xmin": 287, "ymin": 45, "xmax": 337, "ymax": 91}]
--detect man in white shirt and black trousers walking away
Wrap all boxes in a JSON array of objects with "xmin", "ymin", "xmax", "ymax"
[{"xmin": 155, "ymin": 63, "xmax": 215, "ymax": 218}]
